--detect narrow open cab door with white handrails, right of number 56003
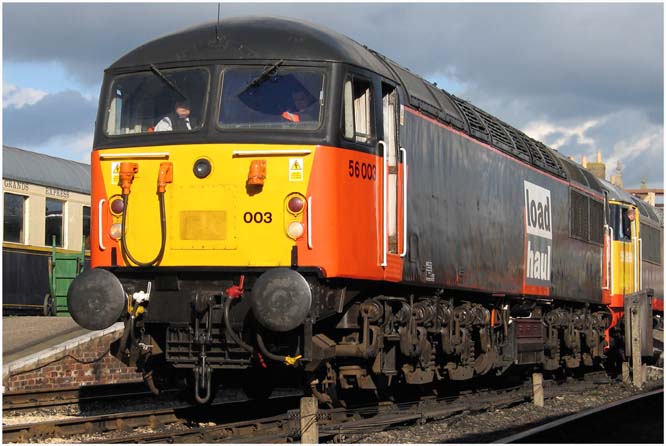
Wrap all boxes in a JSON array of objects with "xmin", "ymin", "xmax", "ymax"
[{"xmin": 379, "ymin": 82, "xmax": 407, "ymax": 280}]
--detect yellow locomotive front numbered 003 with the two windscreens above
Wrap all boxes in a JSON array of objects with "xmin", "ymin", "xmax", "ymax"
[{"xmin": 92, "ymin": 67, "xmax": 324, "ymax": 267}]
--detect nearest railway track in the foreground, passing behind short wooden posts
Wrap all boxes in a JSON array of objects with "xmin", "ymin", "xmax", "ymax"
[{"xmin": 3, "ymin": 379, "xmax": 612, "ymax": 443}]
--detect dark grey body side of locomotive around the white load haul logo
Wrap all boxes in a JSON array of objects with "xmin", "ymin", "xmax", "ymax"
[{"xmin": 401, "ymin": 110, "xmax": 603, "ymax": 303}]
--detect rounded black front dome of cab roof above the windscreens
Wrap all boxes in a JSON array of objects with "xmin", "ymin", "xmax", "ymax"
[{"xmin": 108, "ymin": 17, "xmax": 392, "ymax": 78}]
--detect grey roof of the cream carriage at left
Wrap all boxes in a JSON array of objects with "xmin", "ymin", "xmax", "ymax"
[{"xmin": 2, "ymin": 145, "xmax": 90, "ymax": 195}]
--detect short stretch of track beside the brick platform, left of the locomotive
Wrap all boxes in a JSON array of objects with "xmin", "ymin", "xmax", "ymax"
[{"xmin": 2, "ymin": 381, "xmax": 152, "ymax": 412}]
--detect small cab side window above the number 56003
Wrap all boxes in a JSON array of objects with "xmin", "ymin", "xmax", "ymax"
[{"xmin": 343, "ymin": 77, "xmax": 374, "ymax": 144}]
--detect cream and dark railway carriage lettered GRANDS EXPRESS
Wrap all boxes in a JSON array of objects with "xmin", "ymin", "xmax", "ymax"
[{"xmin": 2, "ymin": 145, "xmax": 91, "ymax": 314}]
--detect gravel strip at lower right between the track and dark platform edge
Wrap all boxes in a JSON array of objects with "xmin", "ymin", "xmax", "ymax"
[{"xmin": 346, "ymin": 374, "xmax": 664, "ymax": 443}]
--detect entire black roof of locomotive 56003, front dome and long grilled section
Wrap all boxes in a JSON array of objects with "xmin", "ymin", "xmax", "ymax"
[{"xmin": 108, "ymin": 17, "xmax": 572, "ymax": 183}]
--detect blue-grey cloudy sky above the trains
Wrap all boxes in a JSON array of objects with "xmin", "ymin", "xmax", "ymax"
[{"xmin": 2, "ymin": 3, "xmax": 664, "ymax": 187}]
